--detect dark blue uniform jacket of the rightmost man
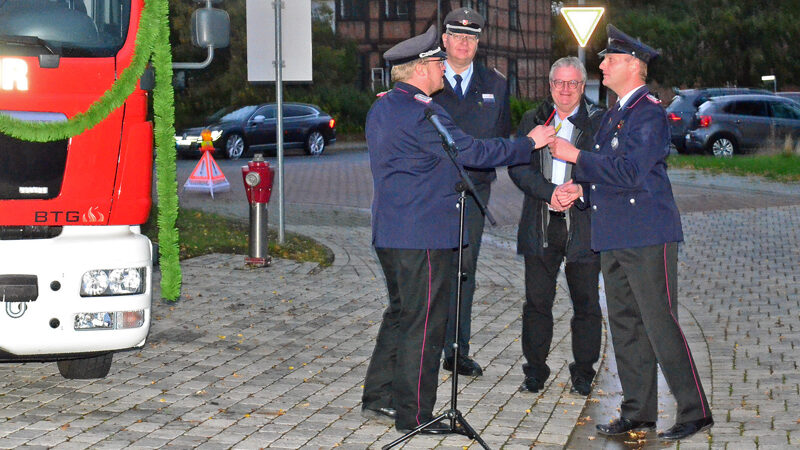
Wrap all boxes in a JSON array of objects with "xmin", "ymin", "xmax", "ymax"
[{"xmin": 575, "ymin": 87, "xmax": 683, "ymax": 251}]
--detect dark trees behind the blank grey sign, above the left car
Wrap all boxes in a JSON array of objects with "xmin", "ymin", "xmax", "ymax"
[{"xmin": 170, "ymin": 0, "xmax": 373, "ymax": 132}]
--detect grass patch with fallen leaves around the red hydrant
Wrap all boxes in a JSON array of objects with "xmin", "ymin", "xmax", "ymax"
[{"xmin": 142, "ymin": 207, "xmax": 333, "ymax": 267}]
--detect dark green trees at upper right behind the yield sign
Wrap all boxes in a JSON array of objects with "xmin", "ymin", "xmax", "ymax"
[{"xmin": 553, "ymin": 0, "xmax": 800, "ymax": 87}]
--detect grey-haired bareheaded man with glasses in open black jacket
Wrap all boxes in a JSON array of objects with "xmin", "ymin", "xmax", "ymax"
[{"xmin": 509, "ymin": 57, "xmax": 604, "ymax": 395}]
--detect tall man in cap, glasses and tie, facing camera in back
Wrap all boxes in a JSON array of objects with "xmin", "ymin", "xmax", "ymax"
[{"xmin": 433, "ymin": 8, "xmax": 511, "ymax": 376}]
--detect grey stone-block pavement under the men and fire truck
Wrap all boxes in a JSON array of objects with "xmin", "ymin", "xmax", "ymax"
[{"xmin": 0, "ymin": 148, "xmax": 800, "ymax": 449}]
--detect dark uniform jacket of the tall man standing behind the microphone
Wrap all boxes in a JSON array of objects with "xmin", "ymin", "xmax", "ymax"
[{"xmin": 433, "ymin": 62, "xmax": 511, "ymax": 188}]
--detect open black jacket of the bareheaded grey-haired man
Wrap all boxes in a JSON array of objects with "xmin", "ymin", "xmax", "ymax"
[{"xmin": 508, "ymin": 97, "xmax": 605, "ymax": 262}]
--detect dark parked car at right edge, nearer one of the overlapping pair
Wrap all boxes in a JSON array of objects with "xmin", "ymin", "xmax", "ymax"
[{"xmin": 685, "ymin": 95, "xmax": 800, "ymax": 156}]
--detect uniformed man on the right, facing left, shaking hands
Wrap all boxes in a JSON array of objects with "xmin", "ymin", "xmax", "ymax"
[{"xmin": 551, "ymin": 25, "xmax": 714, "ymax": 440}]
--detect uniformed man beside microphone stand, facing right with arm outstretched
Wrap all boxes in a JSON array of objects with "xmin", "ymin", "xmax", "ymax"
[{"xmin": 362, "ymin": 27, "xmax": 554, "ymax": 433}]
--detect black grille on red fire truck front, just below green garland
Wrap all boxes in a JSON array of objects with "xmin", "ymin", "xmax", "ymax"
[{"xmin": 0, "ymin": 134, "xmax": 67, "ymax": 200}]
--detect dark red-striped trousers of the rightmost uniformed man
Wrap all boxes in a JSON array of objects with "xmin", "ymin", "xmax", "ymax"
[{"xmin": 601, "ymin": 242, "xmax": 711, "ymax": 423}]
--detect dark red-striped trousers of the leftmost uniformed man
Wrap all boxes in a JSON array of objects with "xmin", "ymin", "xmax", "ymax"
[{"xmin": 362, "ymin": 248, "xmax": 456, "ymax": 429}]
